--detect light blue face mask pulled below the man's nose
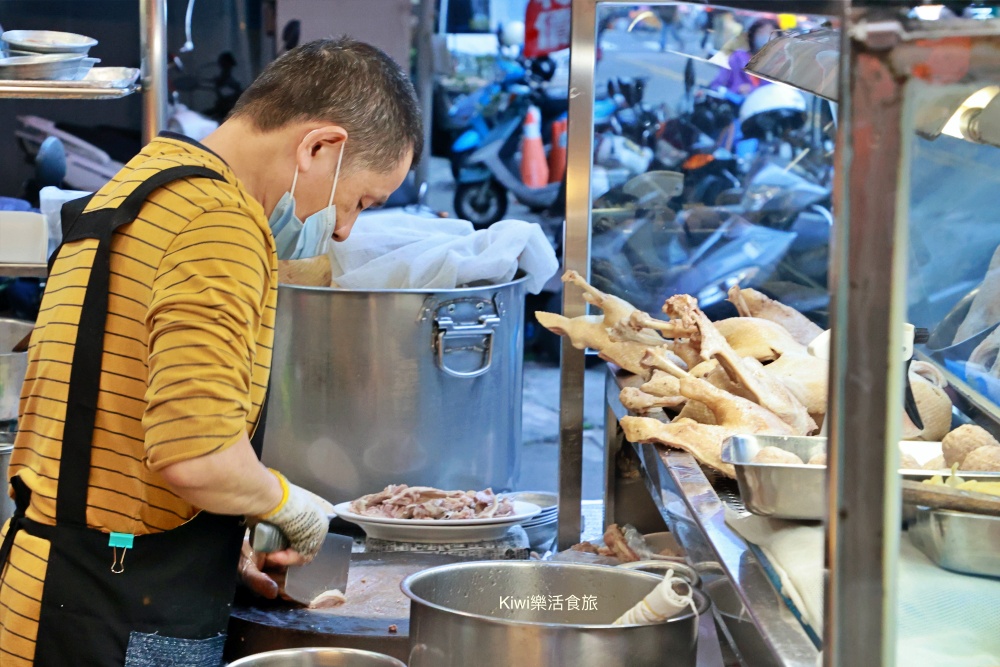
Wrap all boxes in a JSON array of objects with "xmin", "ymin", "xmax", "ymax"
[{"xmin": 267, "ymin": 144, "xmax": 344, "ymax": 259}]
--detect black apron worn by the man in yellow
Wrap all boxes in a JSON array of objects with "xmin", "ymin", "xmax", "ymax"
[{"xmin": 0, "ymin": 166, "xmax": 267, "ymax": 667}]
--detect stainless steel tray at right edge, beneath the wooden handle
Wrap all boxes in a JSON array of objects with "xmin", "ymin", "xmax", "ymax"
[{"xmin": 909, "ymin": 507, "xmax": 1000, "ymax": 578}]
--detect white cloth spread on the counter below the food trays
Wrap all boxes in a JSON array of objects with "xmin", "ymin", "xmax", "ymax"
[{"xmin": 726, "ymin": 511, "xmax": 1000, "ymax": 667}]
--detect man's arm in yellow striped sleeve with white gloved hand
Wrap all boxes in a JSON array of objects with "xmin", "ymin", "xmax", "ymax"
[{"xmin": 143, "ymin": 210, "xmax": 332, "ymax": 559}]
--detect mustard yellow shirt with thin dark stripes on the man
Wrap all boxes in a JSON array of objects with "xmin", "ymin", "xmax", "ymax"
[{"xmin": 0, "ymin": 136, "xmax": 277, "ymax": 665}]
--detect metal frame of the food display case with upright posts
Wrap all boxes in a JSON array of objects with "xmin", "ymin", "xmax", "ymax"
[{"xmin": 559, "ymin": 0, "xmax": 1000, "ymax": 666}]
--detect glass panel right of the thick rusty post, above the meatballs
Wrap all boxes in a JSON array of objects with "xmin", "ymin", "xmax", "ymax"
[{"xmin": 907, "ymin": 43, "xmax": 1000, "ymax": 418}]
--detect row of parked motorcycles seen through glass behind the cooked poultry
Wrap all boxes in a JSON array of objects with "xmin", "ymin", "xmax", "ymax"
[{"xmin": 592, "ymin": 66, "xmax": 835, "ymax": 323}]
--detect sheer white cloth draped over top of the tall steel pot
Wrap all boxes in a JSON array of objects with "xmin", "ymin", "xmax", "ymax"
[{"xmin": 328, "ymin": 209, "xmax": 559, "ymax": 294}]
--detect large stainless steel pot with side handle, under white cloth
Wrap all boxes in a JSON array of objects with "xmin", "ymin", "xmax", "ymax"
[{"xmin": 264, "ymin": 279, "xmax": 524, "ymax": 502}]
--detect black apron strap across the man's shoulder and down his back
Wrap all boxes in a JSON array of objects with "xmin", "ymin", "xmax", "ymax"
[{"xmin": 56, "ymin": 165, "xmax": 224, "ymax": 526}]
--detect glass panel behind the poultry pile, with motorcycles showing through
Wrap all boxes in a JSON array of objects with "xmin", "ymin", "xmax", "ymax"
[{"xmin": 591, "ymin": 4, "xmax": 835, "ymax": 326}]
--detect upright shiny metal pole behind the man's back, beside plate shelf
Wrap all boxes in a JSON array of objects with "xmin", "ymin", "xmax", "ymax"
[{"xmin": 139, "ymin": 0, "xmax": 167, "ymax": 143}]
